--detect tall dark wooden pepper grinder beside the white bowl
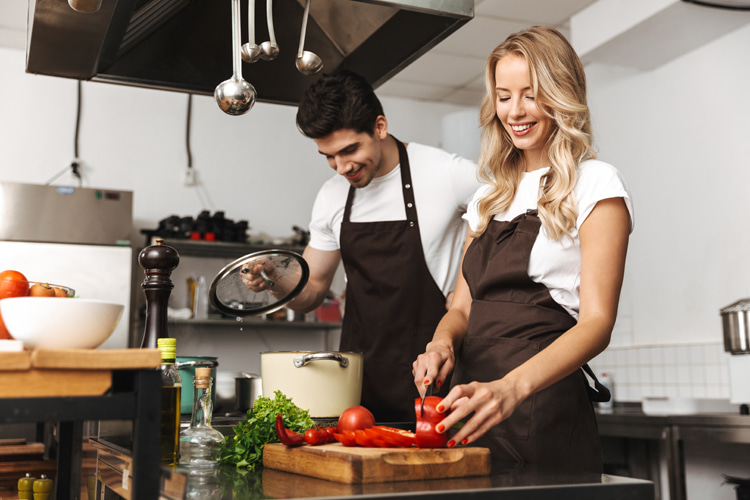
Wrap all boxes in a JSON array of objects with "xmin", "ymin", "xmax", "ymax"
[{"xmin": 138, "ymin": 238, "xmax": 180, "ymax": 349}]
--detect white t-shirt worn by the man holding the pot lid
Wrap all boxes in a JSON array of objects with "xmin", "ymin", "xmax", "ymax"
[{"xmin": 310, "ymin": 142, "xmax": 481, "ymax": 294}]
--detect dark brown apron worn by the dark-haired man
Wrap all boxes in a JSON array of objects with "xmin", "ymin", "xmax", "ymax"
[{"xmin": 340, "ymin": 141, "xmax": 446, "ymax": 422}]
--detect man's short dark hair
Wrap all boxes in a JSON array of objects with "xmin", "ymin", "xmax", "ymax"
[{"xmin": 297, "ymin": 71, "xmax": 384, "ymax": 139}]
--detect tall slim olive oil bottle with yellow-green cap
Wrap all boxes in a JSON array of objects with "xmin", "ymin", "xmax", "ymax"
[{"xmin": 157, "ymin": 338, "xmax": 182, "ymax": 465}]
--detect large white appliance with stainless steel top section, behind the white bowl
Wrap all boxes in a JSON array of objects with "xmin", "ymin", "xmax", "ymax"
[{"xmin": 0, "ymin": 182, "xmax": 133, "ymax": 349}]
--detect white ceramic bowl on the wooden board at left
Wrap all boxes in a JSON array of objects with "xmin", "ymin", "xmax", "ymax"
[{"xmin": 0, "ymin": 297, "xmax": 125, "ymax": 349}]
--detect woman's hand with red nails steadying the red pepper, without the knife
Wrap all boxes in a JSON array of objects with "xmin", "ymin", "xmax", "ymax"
[{"xmin": 436, "ymin": 379, "xmax": 525, "ymax": 448}]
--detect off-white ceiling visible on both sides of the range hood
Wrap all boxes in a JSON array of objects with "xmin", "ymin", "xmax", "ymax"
[{"xmin": 0, "ymin": 0, "xmax": 595, "ymax": 105}]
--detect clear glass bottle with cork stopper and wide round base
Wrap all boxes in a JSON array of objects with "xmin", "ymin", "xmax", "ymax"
[{"xmin": 180, "ymin": 367, "xmax": 224, "ymax": 468}]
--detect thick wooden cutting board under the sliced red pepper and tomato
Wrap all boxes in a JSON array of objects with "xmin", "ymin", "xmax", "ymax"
[{"xmin": 263, "ymin": 443, "xmax": 492, "ymax": 484}]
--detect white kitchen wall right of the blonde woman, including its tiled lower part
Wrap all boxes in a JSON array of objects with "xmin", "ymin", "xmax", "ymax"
[{"xmin": 586, "ymin": 21, "xmax": 750, "ymax": 401}]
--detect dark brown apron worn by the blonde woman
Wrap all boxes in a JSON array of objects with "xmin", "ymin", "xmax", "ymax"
[{"xmin": 453, "ymin": 210, "xmax": 609, "ymax": 472}]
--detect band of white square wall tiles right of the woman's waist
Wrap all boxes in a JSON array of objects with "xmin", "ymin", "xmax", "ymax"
[{"xmin": 589, "ymin": 342, "xmax": 729, "ymax": 402}]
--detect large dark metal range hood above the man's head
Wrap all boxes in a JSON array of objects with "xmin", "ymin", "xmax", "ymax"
[{"xmin": 26, "ymin": 0, "xmax": 474, "ymax": 105}]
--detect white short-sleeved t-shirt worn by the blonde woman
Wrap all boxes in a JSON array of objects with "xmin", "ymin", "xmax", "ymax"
[{"xmin": 464, "ymin": 160, "xmax": 634, "ymax": 319}]
